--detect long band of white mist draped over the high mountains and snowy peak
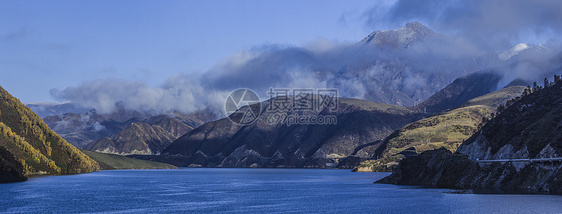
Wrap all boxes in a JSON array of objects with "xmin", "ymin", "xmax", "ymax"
[{"xmin": 51, "ymin": 22, "xmax": 561, "ymax": 116}]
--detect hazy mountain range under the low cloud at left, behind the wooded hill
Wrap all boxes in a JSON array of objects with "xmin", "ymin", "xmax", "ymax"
[{"xmin": 43, "ymin": 105, "xmax": 216, "ymax": 150}]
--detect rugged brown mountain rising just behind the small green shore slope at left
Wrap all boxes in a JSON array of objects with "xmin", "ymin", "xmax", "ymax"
[{"xmin": 87, "ymin": 117, "xmax": 193, "ymax": 155}]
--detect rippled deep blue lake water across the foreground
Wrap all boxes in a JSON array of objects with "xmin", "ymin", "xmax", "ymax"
[{"xmin": 0, "ymin": 168, "xmax": 562, "ymax": 213}]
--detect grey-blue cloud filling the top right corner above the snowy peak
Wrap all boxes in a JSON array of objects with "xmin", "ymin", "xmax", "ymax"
[{"xmin": 364, "ymin": 0, "xmax": 562, "ymax": 50}]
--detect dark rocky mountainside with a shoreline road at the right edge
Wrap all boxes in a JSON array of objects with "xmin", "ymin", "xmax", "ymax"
[{"xmin": 378, "ymin": 77, "xmax": 562, "ymax": 194}]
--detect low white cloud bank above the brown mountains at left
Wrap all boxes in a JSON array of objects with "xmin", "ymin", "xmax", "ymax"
[{"xmin": 50, "ymin": 75, "xmax": 221, "ymax": 114}]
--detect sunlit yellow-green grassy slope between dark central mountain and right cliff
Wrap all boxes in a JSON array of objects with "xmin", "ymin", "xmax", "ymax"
[{"xmin": 356, "ymin": 86, "xmax": 525, "ymax": 171}]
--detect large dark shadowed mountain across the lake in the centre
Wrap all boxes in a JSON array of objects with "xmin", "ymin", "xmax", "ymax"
[{"xmin": 160, "ymin": 98, "xmax": 422, "ymax": 168}]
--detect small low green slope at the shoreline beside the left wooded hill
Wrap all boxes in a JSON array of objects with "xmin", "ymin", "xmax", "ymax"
[{"xmin": 82, "ymin": 150, "xmax": 177, "ymax": 170}]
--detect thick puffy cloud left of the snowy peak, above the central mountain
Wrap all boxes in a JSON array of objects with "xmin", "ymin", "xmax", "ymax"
[{"xmin": 202, "ymin": 44, "xmax": 345, "ymax": 92}]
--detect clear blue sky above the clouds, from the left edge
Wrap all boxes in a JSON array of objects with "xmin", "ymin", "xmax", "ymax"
[{"xmin": 0, "ymin": 0, "xmax": 390, "ymax": 103}]
